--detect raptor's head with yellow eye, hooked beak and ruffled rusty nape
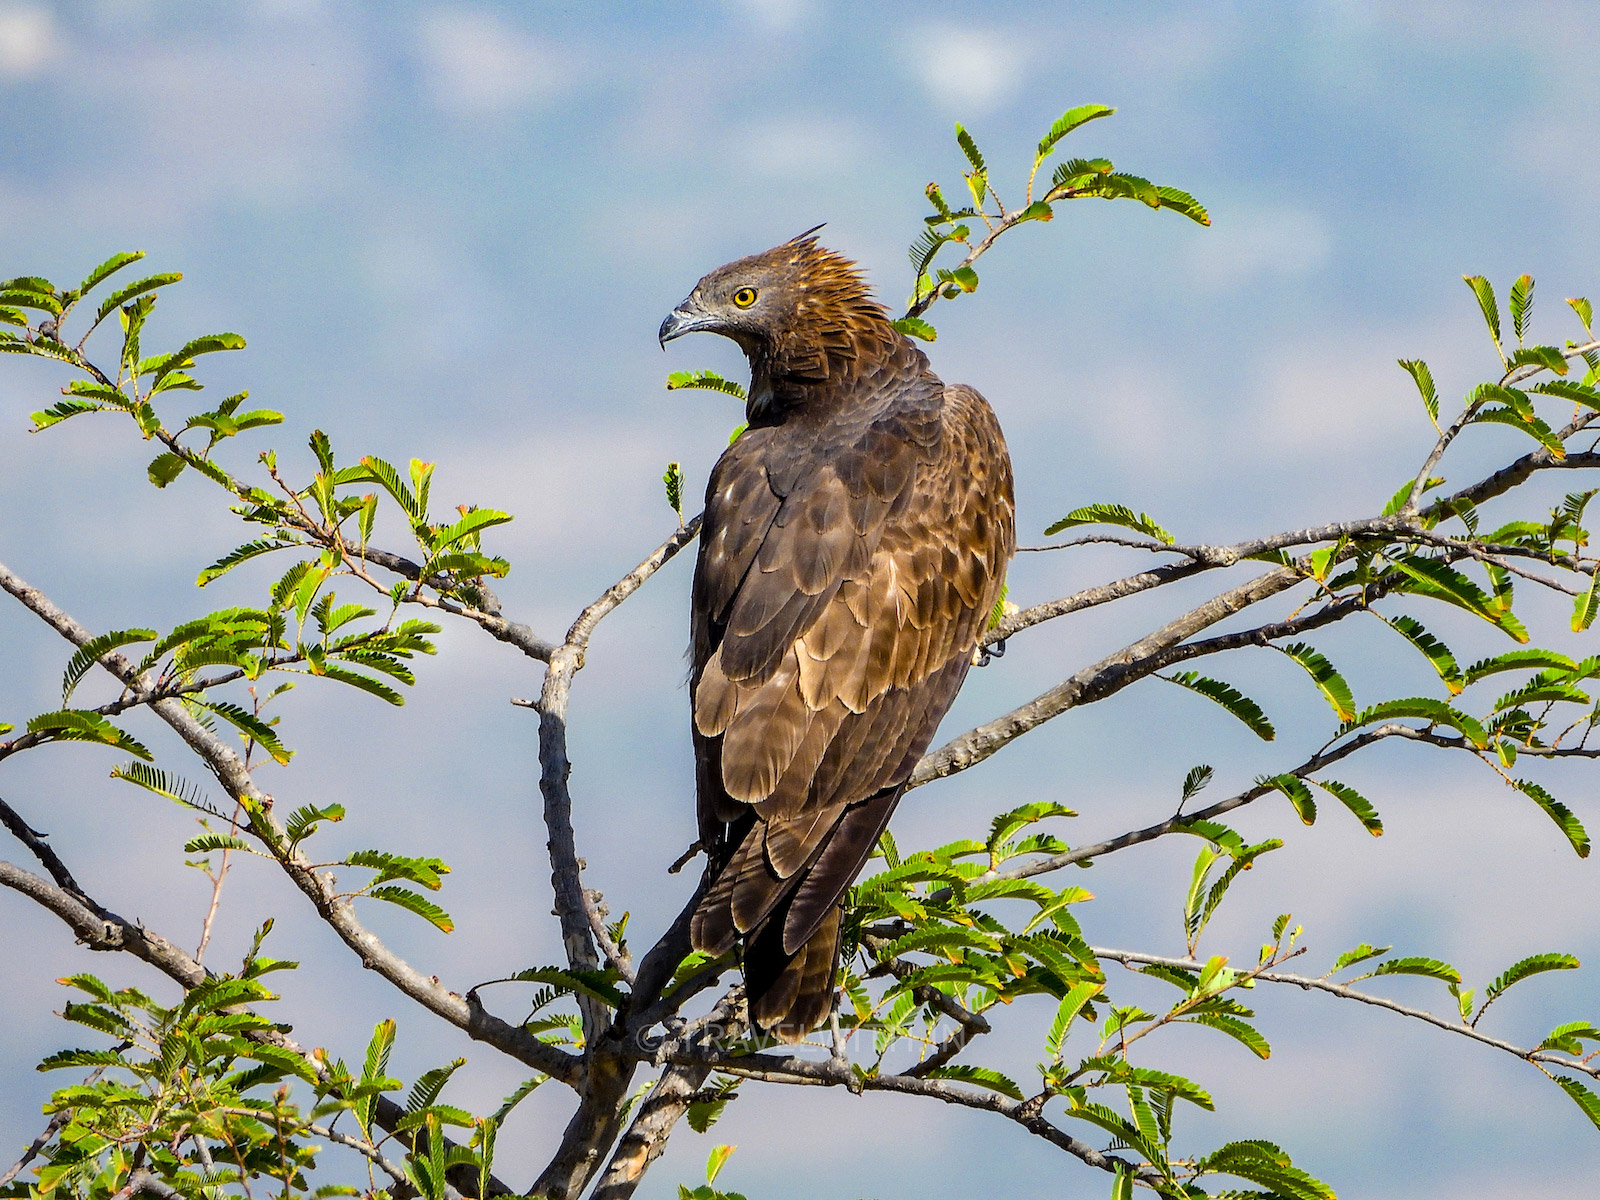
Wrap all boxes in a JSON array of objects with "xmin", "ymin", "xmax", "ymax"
[{"xmin": 661, "ymin": 226, "xmax": 898, "ymax": 381}]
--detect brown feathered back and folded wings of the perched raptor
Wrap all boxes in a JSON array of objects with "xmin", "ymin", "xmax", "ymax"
[{"xmin": 691, "ymin": 376, "xmax": 1014, "ymax": 992}]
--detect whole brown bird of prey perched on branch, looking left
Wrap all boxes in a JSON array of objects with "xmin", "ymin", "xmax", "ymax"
[{"xmin": 661, "ymin": 230, "xmax": 1016, "ymax": 1042}]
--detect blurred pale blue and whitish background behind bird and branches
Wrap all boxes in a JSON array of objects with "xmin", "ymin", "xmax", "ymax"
[{"xmin": 0, "ymin": 0, "xmax": 1600, "ymax": 1200}]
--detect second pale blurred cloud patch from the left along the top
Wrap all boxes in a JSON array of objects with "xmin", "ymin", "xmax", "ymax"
[{"xmin": 418, "ymin": 10, "xmax": 571, "ymax": 115}]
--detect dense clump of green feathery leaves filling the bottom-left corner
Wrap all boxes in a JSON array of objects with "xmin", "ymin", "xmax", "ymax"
[{"xmin": 0, "ymin": 947, "xmax": 515, "ymax": 1200}]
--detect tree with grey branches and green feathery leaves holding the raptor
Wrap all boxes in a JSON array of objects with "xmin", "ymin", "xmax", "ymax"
[{"xmin": 0, "ymin": 106, "xmax": 1600, "ymax": 1200}]
